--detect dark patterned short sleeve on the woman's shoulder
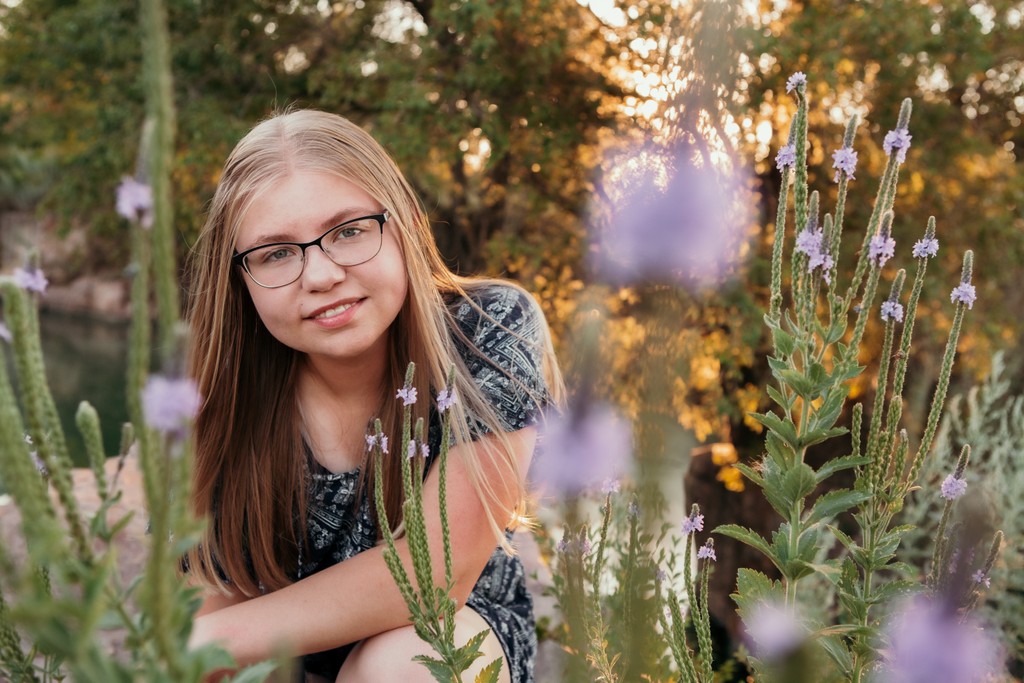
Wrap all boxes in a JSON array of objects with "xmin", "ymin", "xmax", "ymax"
[{"xmin": 454, "ymin": 286, "xmax": 549, "ymax": 433}]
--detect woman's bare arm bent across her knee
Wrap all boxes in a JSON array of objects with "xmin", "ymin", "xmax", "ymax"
[{"xmin": 190, "ymin": 428, "xmax": 537, "ymax": 666}]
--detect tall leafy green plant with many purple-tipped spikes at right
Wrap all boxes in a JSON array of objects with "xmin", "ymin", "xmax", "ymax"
[{"xmin": 716, "ymin": 74, "xmax": 1000, "ymax": 681}]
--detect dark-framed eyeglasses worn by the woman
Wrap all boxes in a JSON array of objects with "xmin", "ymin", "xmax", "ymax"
[{"xmin": 231, "ymin": 211, "xmax": 391, "ymax": 290}]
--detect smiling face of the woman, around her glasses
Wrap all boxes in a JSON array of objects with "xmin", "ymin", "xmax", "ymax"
[{"xmin": 234, "ymin": 170, "xmax": 409, "ymax": 374}]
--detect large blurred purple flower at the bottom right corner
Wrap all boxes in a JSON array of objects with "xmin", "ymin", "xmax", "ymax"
[{"xmin": 879, "ymin": 596, "xmax": 1002, "ymax": 683}]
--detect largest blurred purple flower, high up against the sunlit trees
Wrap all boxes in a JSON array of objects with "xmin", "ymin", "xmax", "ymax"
[{"xmin": 589, "ymin": 139, "xmax": 750, "ymax": 288}]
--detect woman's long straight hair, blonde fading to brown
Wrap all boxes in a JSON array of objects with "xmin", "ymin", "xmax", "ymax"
[{"xmin": 186, "ymin": 110, "xmax": 563, "ymax": 596}]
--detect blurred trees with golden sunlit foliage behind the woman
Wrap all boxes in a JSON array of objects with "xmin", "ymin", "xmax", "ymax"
[{"xmin": 0, "ymin": 0, "xmax": 1024, "ymax": 667}]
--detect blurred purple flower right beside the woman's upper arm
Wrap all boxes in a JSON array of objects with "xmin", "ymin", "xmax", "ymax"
[{"xmin": 530, "ymin": 403, "xmax": 633, "ymax": 496}]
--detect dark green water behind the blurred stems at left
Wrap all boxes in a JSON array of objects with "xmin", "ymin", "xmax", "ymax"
[{"xmin": 39, "ymin": 311, "xmax": 129, "ymax": 466}]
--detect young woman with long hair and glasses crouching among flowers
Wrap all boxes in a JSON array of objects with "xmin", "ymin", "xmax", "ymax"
[{"xmin": 185, "ymin": 111, "xmax": 562, "ymax": 683}]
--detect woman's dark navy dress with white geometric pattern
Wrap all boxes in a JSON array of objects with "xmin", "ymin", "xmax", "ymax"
[{"xmin": 298, "ymin": 286, "xmax": 548, "ymax": 683}]
